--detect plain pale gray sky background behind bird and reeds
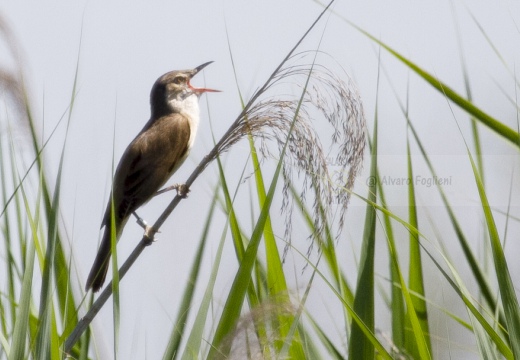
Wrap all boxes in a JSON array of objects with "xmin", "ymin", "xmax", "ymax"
[{"xmin": 0, "ymin": 0, "xmax": 520, "ymax": 359}]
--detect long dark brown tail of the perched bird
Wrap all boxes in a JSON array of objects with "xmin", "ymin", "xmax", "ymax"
[{"xmin": 85, "ymin": 217, "xmax": 125, "ymax": 292}]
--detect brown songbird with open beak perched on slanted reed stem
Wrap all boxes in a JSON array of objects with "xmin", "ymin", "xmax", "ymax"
[{"xmin": 86, "ymin": 61, "xmax": 218, "ymax": 292}]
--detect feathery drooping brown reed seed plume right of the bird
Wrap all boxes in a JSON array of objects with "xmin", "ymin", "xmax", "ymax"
[{"xmin": 213, "ymin": 54, "xmax": 366, "ymax": 251}]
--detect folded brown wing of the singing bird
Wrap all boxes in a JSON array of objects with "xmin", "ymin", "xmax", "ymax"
[{"xmin": 102, "ymin": 114, "xmax": 190, "ymax": 226}]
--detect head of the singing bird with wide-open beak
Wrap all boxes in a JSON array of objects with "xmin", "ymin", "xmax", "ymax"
[{"xmin": 150, "ymin": 61, "xmax": 220, "ymax": 115}]
